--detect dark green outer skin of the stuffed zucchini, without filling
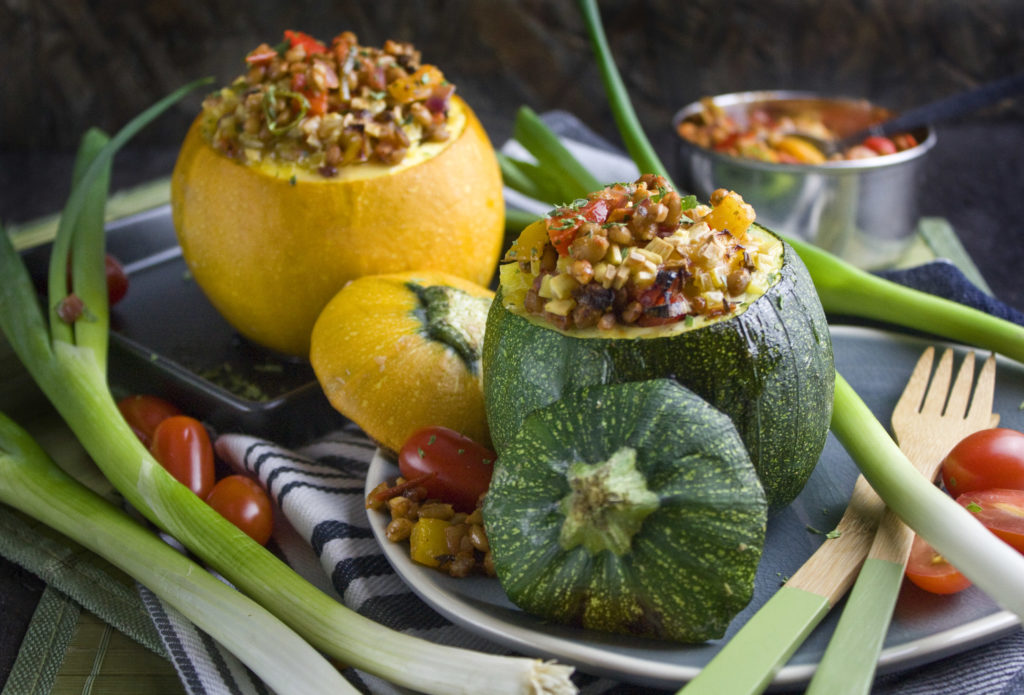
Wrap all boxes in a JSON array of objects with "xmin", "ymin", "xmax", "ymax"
[{"xmin": 482, "ymin": 231, "xmax": 835, "ymax": 507}]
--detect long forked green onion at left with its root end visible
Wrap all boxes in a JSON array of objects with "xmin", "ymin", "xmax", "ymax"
[{"xmin": 0, "ymin": 81, "xmax": 575, "ymax": 695}]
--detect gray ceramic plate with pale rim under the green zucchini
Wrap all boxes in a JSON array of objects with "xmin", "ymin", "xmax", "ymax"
[{"xmin": 367, "ymin": 327, "xmax": 1024, "ymax": 689}]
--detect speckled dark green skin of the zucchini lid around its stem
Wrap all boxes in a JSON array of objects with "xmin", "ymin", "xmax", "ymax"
[{"xmin": 483, "ymin": 379, "xmax": 767, "ymax": 643}]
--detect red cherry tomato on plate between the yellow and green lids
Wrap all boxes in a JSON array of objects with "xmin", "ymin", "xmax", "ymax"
[{"xmin": 398, "ymin": 427, "xmax": 496, "ymax": 512}]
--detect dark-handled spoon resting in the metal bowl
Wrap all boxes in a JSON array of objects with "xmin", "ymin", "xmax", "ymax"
[{"xmin": 791, "ymin": 73, "xmax": 1024, "ymax": 159}]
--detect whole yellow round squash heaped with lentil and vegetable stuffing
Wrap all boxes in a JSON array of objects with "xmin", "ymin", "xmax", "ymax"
[{"xmin": 171, "ymin": 32, "xmax": 505, "ymax": 356}]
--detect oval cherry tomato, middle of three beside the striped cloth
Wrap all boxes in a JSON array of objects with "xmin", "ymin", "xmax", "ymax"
[{"xmin": 150, "ymin": 415, "xmax": 214, "ymax": 498}]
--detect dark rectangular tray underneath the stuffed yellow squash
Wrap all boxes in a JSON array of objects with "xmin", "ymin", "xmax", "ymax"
[{"xmin": 25, "ymin": 206, "xmax": 345, "ymax": 446}]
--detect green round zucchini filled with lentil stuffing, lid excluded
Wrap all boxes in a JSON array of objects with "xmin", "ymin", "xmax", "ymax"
[{"xmin": 482, "ymin": 175, "xmax": 835, "ymax": 507}]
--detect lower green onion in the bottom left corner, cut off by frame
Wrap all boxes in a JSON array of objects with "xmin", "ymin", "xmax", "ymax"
[{"xmin": 0, "ymin": 414, "xmax": 358, "ymax": 694}]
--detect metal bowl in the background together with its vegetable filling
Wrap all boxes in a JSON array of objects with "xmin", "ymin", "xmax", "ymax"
[{"xmin": 673, "ymin": 91, "xmax": 936, "ymax": 268}]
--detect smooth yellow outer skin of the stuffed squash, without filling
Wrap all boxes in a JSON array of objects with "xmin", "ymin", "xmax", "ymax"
[{"xmin": 171, "ymin": 97, "xmax": 505, "ymax": 356}]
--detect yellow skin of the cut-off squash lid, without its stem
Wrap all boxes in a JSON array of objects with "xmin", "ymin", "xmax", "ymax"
[{"xmin": 309, "ymin": 271, "xmax": 494, "ymax": 451}]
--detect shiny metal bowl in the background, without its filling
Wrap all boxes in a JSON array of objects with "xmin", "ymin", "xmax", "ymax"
[{"xmin": 673, "ymin": 91, "xmax": 936, "ymax": 268}]
